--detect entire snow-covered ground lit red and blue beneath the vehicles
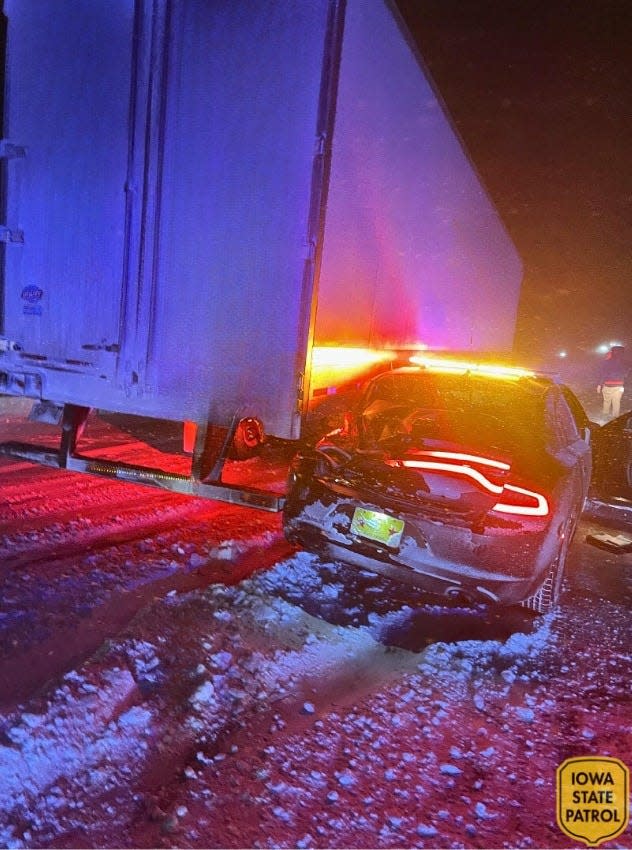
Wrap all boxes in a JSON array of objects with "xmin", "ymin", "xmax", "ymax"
[{"xmin": 0, "ymin": 408, "xmax": 632, "ymax": 848}]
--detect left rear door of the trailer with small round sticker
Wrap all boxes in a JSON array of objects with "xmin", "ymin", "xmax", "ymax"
[{"xmin": 0, "ymin": 0, "xmax": 134, "ymax": 377}]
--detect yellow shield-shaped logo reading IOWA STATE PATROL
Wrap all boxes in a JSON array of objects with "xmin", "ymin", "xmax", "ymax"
[{"xmin": 557, "ymin": 756, "xmax": 630, "ymax": 847}]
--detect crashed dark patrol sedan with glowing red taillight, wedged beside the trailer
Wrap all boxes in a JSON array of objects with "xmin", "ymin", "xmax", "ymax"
[{"xmin": 284, "ymin": 363, "xmax": 592, "ymax": 613}]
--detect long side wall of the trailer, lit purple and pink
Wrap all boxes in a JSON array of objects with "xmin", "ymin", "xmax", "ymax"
[{"xmin": 316, "ymin": 0, "xmax": 522, "ymax": 351}]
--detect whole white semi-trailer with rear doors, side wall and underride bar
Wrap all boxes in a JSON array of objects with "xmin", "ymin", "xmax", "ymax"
[{"xmin": 0, "ymin": 0, "xmax": 521, "ymax": 510}]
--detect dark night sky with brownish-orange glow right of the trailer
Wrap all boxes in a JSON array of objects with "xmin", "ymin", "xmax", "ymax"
[{"xmin": 398, "ymin": 0, "xmax": 632, "ymax": 360}]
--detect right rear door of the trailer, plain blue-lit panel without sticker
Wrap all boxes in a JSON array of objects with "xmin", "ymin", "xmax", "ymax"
[{"xmin": 139, "ymin": 0, "xmax": 339, "ymax": 437}]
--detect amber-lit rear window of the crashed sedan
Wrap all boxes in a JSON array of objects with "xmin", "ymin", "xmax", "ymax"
[{"xmin": 361, "ymin": 372, "xmax": 545, "ymax": 452}]
